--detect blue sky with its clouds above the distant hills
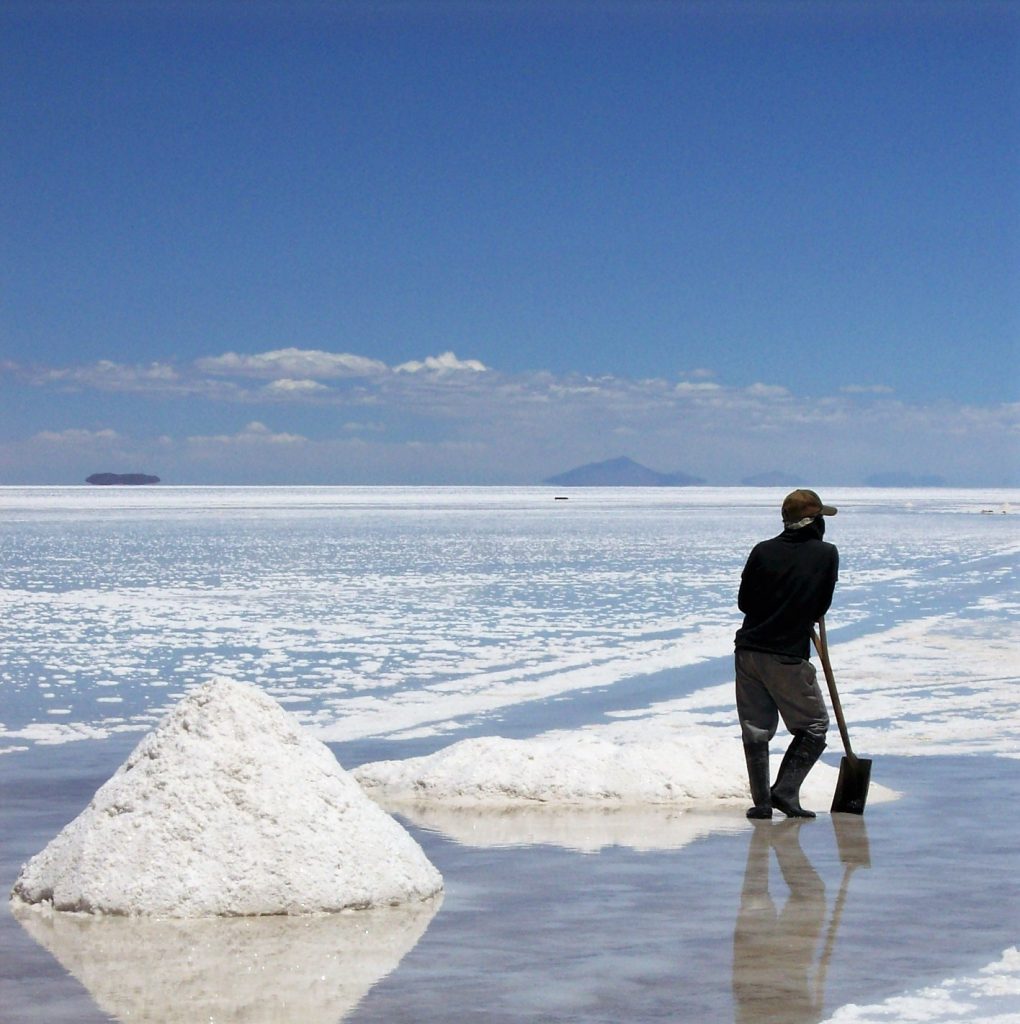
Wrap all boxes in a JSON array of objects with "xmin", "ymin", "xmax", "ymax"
[{"xmin": 0, "ymin": 0, "xmax": 1020, "ymax": 485}]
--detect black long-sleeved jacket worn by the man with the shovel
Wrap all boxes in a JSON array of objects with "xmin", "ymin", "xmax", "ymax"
[{"xmin": 734, "ymin": 523, "xmax": 840, "ymax": 658}]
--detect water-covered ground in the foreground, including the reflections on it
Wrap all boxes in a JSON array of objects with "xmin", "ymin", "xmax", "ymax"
[{"xmin": 0, "ymin": 739, "xmax": 1020, "ymax": 1024}]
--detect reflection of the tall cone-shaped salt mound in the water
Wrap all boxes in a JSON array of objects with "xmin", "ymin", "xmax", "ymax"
[{"xmin": 14, "ymin": 900, "xmax": 440, "ymax": 1024}]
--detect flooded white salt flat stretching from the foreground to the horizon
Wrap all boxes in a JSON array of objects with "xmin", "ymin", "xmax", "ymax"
[{"xmin": 0, "ymin": 486, "xmax": 1020, "ymax": 1021}]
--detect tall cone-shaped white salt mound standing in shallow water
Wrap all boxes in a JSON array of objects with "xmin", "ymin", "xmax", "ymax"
[{"xmin": 11, "ymin": 679, "xmax": 442, "ymax": 918}]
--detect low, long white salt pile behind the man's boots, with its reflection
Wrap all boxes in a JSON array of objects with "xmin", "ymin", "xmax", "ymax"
[{"xmin": 353, "ymin": 722, "xmax": 897, "ymax": 852}]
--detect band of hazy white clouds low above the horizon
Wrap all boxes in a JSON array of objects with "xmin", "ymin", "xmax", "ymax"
[{"xmin": 0, "ymin": 349, "xmax": 1020, "ymax": 485}]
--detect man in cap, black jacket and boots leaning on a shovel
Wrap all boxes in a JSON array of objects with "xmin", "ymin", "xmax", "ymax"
[{"xmin": 734, "ymin": 490, "xmax": 840, "ymax": 818}]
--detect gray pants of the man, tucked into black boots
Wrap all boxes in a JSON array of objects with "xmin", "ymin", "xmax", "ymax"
[{"xmin": 734, "ymin": 649, "xmax": 828, "ymax": 743}]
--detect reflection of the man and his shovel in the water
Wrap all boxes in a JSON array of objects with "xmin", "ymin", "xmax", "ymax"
[{"xmin": 733, "ymin": 814, "xmax": 870, "ymax": 1024}]
